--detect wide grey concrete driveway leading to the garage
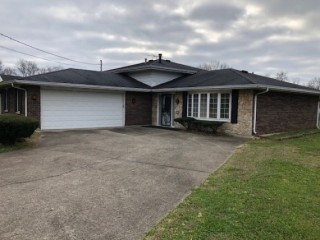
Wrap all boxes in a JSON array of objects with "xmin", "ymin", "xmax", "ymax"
[{"xmin": 0, "ymin": 127, "xmax": 244, "ymax": 240}]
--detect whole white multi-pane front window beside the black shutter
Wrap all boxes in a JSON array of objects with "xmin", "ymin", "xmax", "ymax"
[{"xmin": 187, "ymin": 92, "xmax": 231, "ymax": 121}]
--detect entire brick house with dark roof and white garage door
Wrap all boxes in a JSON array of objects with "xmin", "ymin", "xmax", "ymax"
[{"xmin": 0, "ymin": 55, "xmax": 320, "ymax": 136}]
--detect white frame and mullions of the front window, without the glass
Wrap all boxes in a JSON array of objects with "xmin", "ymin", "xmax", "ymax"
[{"xmin": 187, "ymin": 91, "xmax": 232, "ymax": 122}]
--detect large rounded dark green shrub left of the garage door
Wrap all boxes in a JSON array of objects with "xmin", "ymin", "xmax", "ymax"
[{"xmin": 0, "ymin": 114, "xmax": 39, "ymax": 145}]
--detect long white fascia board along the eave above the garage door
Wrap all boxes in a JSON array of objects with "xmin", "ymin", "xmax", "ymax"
[{"xmin": 14, "ymin": 80, "xmax": 150, "ymax": 92}]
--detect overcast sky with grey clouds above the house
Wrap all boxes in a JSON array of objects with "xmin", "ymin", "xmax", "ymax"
[{"xmin": 0, "ymin": 0, "xmax": 320, "ymax": 83}]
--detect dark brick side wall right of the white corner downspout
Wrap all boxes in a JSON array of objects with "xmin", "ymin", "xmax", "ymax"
[{"xmin": 256, "ymin": 92, "xmax": 319, "ymax": 134}]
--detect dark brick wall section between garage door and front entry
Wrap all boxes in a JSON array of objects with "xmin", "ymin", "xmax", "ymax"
[{"xmin": 125, "ymin": 92, "xmax": 152, "ymax": 125}]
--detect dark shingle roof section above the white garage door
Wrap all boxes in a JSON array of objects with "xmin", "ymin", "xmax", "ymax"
[{"xmin": 24, "ymin": 68, "xmax": 150, "ymax": 88}]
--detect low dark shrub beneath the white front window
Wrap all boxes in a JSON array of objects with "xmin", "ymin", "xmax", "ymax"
[{"xmin": 174, "ymin": 117, "xmax": 223, "ymax": 133}]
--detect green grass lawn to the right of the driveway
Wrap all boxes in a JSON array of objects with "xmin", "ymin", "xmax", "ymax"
[{"xmin": 145, "ymin": 134, "xmax": 320, "ymax": 240}]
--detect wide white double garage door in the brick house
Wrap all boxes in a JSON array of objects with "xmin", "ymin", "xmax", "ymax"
[{"xmin": 41, "ymin": 89, "xmax": 124, "ymax": 129}]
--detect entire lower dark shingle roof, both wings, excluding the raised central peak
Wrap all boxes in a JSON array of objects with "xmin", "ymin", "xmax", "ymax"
[{"xmin": 1, "ymin": 68, "xmax": 320, "ymax": 93}]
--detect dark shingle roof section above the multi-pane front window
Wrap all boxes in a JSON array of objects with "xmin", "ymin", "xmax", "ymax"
[{"xmin": 155, "ymin": 68, "xmax": 314, "ymax": 90}]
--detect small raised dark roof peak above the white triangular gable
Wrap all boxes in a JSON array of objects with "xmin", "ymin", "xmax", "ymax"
[{"xmin": 108, "ymin": 59, "xmax": 204, "ymax": 73}]
